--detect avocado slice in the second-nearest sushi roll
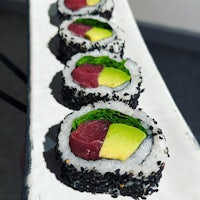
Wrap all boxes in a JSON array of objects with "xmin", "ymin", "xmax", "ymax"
[{"xmin": 98, "ymin": 67, "xmax": 131, "ymax": 88}]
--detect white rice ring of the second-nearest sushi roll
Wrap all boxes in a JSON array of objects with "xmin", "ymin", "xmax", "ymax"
[{"xmin": 62, "ymin": 50, "xmax": 142, "ymax": 100}]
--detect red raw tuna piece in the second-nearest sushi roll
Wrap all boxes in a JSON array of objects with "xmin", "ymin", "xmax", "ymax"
[{"xmin": 72, "ymin": 63, "xmax": 103, "ymax": 88}]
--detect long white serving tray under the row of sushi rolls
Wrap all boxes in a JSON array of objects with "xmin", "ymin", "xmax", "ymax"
[{"xmin": 24, "ymin": 0, "xmax": 200, "ymax": 200}]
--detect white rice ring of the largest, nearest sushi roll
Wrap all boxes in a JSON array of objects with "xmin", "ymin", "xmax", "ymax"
[{"xmin": 58, "ymin": 101, "xmax": 168, "ymax": 176}]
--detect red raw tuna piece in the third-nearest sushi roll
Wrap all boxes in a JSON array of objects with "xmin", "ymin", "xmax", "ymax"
[{"xmin": 68, "ymin": 23, "xmax": 92, "ymax": 37}]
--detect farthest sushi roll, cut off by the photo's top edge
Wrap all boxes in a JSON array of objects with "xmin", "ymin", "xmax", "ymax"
[{"xmin": 58, "ymin": 0, "xmax": 114, "ymax": 19}]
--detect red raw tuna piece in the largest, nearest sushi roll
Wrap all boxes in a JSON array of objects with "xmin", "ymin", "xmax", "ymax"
[{"xmin": 69, "ymin": 120, "xmax": 111, "ymax": 160}]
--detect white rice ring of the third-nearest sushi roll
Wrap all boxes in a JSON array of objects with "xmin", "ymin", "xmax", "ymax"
[{"xmin": 59, "ymin": 16, "xmax": 125, "ymax": 54}]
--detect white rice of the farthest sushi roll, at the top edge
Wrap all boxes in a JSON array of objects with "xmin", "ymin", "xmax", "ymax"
[{"xmin": 58, "ymin": 0, "xmax": 114, "ymax": 16}]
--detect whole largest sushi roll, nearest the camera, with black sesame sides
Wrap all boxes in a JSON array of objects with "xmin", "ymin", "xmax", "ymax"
[{"xmin": 56, "ymin": 101, "xmax": 169, "ymax": 199}]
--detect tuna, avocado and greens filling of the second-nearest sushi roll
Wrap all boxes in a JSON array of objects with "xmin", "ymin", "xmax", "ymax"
[{"xmin": 72, "ymin": 56, "xmax": 131, "ymax": 88}]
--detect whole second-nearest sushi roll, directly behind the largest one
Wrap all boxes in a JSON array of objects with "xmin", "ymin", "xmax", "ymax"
[{"xmin": 62, "ymin": 50, "xmax": 142, "ymax": 110}]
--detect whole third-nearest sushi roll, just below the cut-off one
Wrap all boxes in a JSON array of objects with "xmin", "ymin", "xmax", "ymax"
[{"xmin": 58, "ymin": 16, "xmax": 125, "ymax": 64}]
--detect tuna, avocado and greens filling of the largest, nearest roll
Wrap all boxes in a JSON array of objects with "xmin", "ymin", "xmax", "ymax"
[{"xmin": 69, "ymin": 109, "xmax": 146, "ymax": 160}]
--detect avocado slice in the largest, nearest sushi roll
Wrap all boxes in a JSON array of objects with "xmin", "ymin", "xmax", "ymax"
[{"xmin": 99, "ymin": 123, "xmax": 146, "ymax": 160}]
